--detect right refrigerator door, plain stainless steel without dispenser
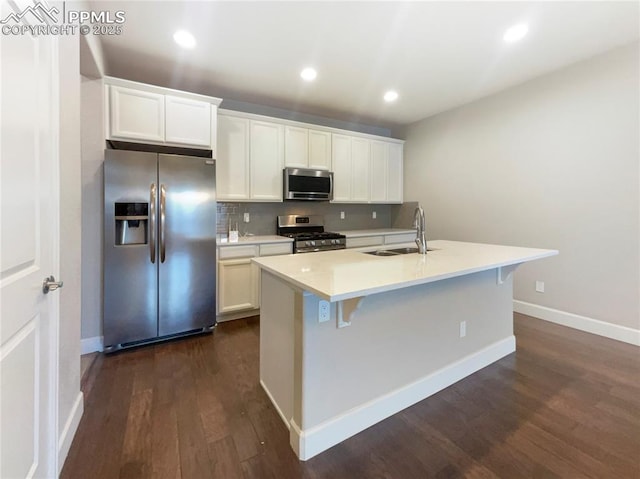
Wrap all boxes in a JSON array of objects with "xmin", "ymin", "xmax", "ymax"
[{"xmin": 158, "ymin": 155, "xmax": 216, "ymax": 336}]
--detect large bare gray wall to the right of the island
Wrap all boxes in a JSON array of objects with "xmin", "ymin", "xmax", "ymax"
[{"xmin": 404, "ymin": 43, "xmax": 640, "ymax": 329}]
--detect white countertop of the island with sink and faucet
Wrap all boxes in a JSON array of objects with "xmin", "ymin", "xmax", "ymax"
[{"xmin": 253, "ymin": 240, "xmax": 558, "ymax": 301}]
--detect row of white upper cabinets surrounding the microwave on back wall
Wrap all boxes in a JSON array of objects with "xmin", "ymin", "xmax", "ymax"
[{"xmin": 217, "ymin": 110, "xmax": 402, "ymax": 203}]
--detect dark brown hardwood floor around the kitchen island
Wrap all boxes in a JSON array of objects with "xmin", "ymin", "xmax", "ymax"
[{"xmin": 62, "ymin": 315, "xmax": 640, "ymax": 479}]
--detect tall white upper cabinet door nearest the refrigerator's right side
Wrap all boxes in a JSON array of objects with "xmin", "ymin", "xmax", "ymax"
[{"xmin": 216, "ymin": 115, "xmax": 249, "ymax": 200}]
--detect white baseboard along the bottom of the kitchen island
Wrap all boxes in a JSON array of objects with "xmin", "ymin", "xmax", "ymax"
[{"xmin": 289, "ymin": 336, "xmax": 516, "ymax": 461}]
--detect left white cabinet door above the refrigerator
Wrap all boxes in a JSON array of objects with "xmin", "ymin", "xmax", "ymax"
[{"xmin": 109, "ymin": 85, "xmax": 164, "ymax": 142}]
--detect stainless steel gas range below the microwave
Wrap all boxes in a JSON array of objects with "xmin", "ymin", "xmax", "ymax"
[{"xmin": 276, "ymin": 215, "xmax": 347, "ymax": 253}]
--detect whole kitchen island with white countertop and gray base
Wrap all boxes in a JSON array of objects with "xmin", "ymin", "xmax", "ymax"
[{"xmin": 253, "ymin": 241, "xmax": 558, "ymax": 460}]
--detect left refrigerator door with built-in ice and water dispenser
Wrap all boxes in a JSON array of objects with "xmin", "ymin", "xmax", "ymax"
[{"xmin": 104, "ymin": 150, "xmax": 158, "ymax": 348}]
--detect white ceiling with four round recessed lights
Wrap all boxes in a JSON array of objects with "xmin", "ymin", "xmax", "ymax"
[{"xmin": 90, "ymin": 1, "xmax": 640, "ymax": 127}]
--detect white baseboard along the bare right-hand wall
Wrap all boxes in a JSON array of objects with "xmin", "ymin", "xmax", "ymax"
[{"xmin": 513, "ymin": 299, "xmax": 640, "ymax": 346}]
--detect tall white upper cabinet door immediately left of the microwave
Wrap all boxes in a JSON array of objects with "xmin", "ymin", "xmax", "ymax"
[{"xmin": 249, "ymin": 120, "xmax": 284, "ymax": 201}]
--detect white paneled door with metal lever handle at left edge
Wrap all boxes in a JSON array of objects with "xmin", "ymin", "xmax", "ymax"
[{"xmin": 0, "ymin": 2, "xmax": 59, "ymax": 478}]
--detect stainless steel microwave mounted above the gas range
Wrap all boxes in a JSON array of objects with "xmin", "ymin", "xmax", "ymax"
[{"xmin": 282, "ymin": 168, "xmax": 333, "ymax": 201}]
